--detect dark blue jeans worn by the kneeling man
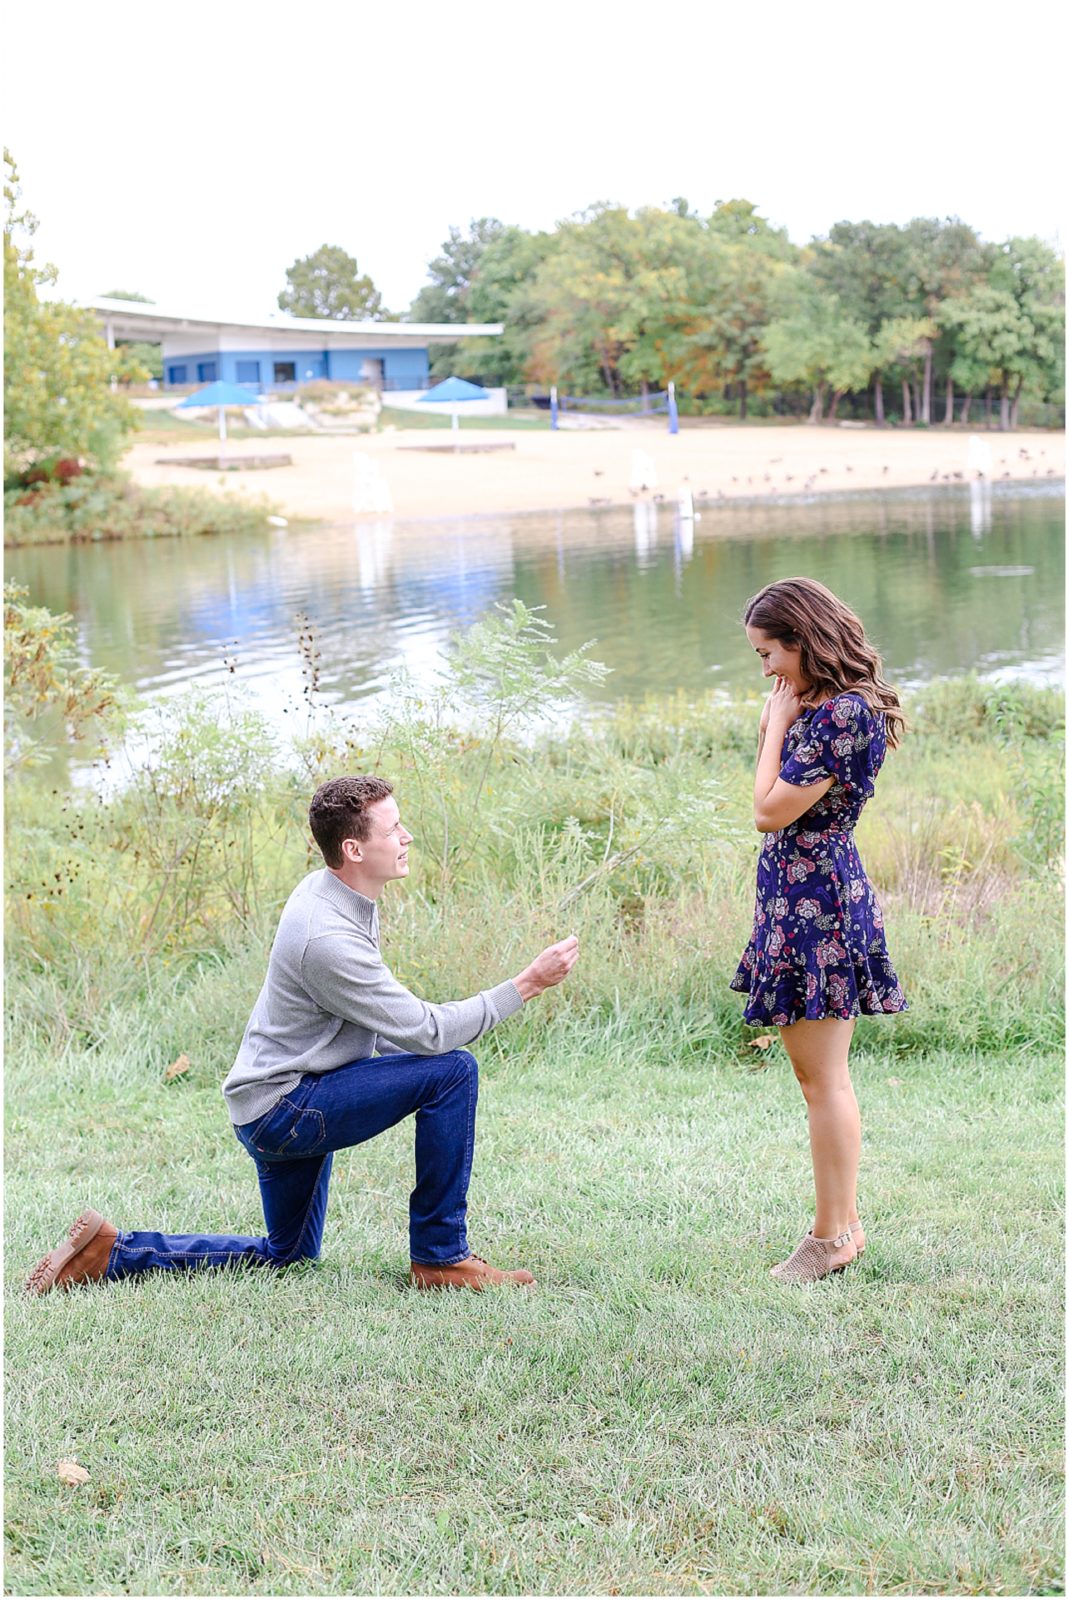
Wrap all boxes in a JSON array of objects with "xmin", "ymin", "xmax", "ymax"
[{"xmin": 106, "ymin": 1050, "xmax": 478, "ymax": 1278}]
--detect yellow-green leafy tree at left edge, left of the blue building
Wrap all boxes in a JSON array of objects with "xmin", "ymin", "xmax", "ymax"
[{"xmin": 3, "ymin": 150, "xmax": 136, "ymax": 480}]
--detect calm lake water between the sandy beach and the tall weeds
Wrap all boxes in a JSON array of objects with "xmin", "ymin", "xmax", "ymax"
[{"xmin": 6, "ymin": 485, "xmax": 1064, "ymax": 732}]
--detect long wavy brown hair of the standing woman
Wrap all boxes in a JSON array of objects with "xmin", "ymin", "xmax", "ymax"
[{"xmin": 743, "ymin": 578, "xmax": 906, "ymax": 749}]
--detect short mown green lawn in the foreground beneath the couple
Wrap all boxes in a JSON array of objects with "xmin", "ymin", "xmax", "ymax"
[{"xmin": 6, "ymin": 1030, "xmax": 1063, "ymax": 1595}]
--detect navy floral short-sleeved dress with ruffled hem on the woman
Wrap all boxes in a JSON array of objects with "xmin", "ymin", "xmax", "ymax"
[{"xmin": 731, "ymin": 694, "xmax": 906, "ymax": 1027}]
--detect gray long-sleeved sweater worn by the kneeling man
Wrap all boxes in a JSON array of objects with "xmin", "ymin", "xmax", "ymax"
[{"xmin": 222, "ymin": 867, "xmax": 523, "ymax": 1128}]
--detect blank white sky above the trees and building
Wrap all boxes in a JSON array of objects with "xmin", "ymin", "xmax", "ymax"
[{"xmin": 5, "ymin": 0, "xmax": 1064, "ymax": 315}]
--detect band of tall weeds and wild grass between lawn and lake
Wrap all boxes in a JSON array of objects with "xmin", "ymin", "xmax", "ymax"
[{"xmin": 6, "ymin": 603, "xmax": 1063, "ymax": 1070}]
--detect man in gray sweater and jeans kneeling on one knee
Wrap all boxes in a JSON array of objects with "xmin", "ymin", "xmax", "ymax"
[{"xmin": 26, "ymin": 778, "xmax": 579, "ymax": 1294}]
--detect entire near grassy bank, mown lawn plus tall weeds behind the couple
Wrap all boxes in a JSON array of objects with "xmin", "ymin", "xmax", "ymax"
[{"xmin": 6, "ymin": 643, "xmax": 1063, "ymax": 1594}]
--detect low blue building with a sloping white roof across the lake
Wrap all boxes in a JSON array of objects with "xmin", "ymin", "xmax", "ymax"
[{"xmin": 88, "ymin": 299, "xmax": 504, "ymax": 395}]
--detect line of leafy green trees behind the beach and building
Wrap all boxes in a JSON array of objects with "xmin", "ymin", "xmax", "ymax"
[{"xmin": 278, "ymin": 198, "xmax": 1064, "ymax": 427}]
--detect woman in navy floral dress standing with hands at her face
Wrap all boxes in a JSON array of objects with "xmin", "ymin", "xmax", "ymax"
[{"xmin": 731, "ymin": 578, "xmax": 906, "ymax": 1283}]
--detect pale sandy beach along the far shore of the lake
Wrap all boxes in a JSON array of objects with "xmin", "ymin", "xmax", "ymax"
[{"xmin": 125, "ymin": 422, "xmax": 1066, "ymax": 522}]
